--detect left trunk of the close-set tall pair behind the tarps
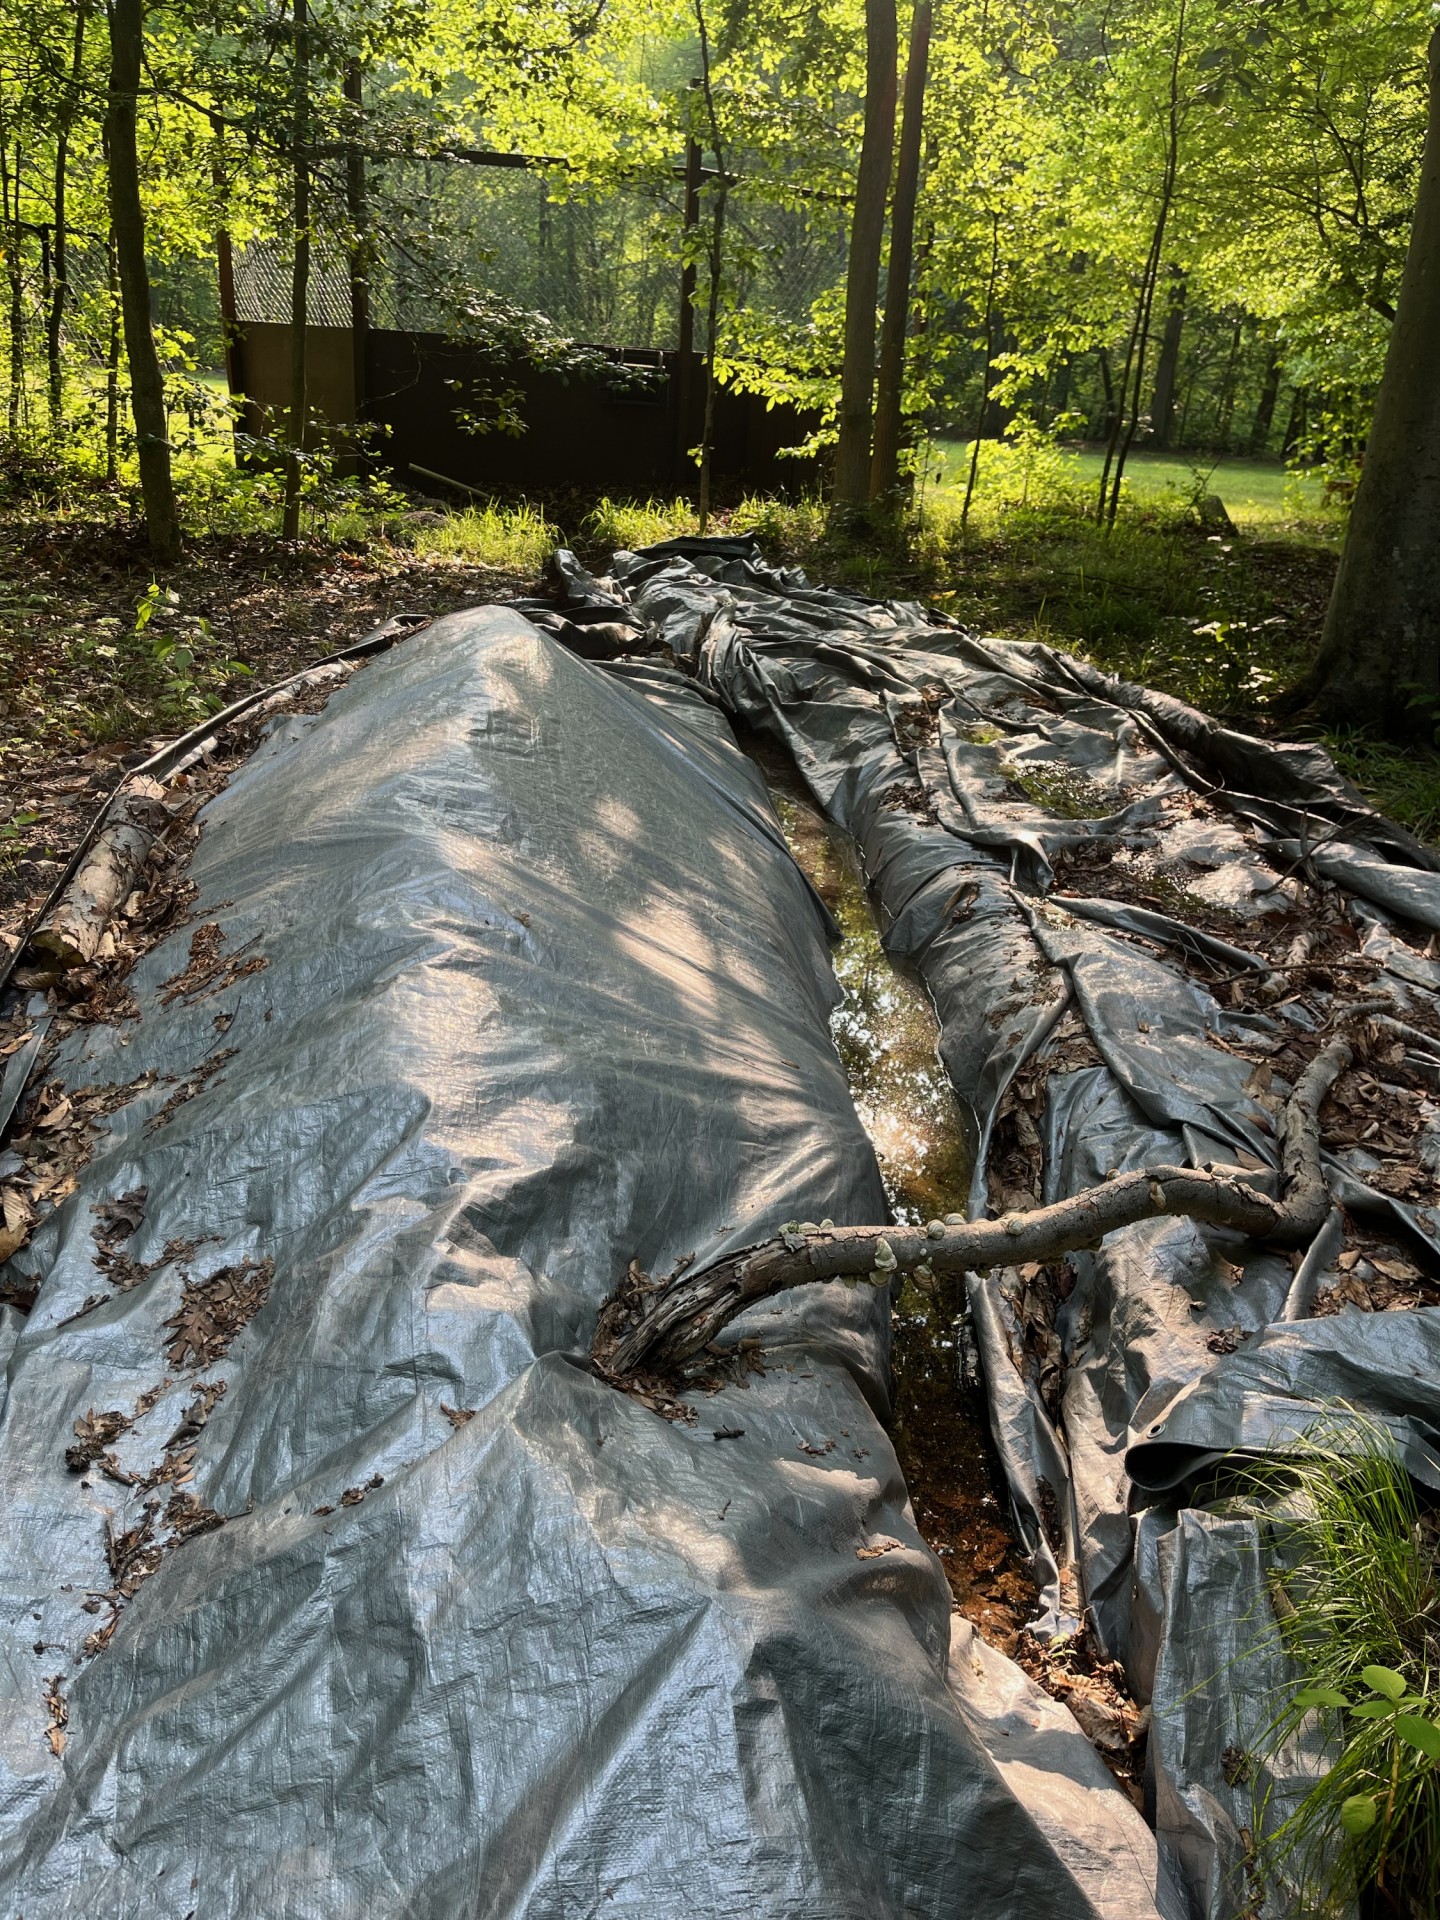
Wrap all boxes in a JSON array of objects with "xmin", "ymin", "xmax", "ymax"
[{"xmin": 835, "ymin": 0, "xmax": 897, "ymax": 509}]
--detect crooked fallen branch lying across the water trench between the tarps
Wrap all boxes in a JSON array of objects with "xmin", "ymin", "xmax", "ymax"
[{"xmin": 591, "ymin": 1041, "xmax": 1352, "ymax": 1379}]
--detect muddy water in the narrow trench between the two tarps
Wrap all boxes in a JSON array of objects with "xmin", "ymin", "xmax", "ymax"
[{"xmin": 747, "ymin": 741, "xmax": 1035, "ymax": 1653}]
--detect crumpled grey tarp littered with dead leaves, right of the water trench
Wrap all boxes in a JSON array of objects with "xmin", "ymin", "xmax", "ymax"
[{"xmin": 549, "ymin": 540, "xmax": 1440, "ymax": 1920}]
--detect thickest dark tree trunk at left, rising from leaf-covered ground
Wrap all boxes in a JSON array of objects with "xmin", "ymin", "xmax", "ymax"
[{"xmin": 106, "ymin": 0, "xmax": 180, "ymax": 561}]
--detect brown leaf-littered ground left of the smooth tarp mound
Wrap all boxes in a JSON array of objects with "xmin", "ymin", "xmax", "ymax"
[{"xmin": 0, "ymin": 522, "xmax": 538, "ymax": 948}]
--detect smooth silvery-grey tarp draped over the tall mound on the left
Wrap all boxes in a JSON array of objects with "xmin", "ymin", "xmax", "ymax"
[{"xmin": 0, "ymin": 609, "xmax": 1179, "ymax": 1920}]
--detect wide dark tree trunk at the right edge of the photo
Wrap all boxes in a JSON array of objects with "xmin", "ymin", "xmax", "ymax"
[{"xmin": 1308, "ymin": 29, "xmax": 1440, "ymax": 739}]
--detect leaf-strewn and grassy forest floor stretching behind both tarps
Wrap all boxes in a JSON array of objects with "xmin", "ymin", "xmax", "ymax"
[{"xmin": 0, "ymin": 472, "xmax": 1440, "ymax": 967}]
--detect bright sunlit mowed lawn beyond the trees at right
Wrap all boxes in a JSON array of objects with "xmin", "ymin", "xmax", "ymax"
[{"xmin": 929, "ymin": 440, "xmax": 1325, "ymax": 528}]
